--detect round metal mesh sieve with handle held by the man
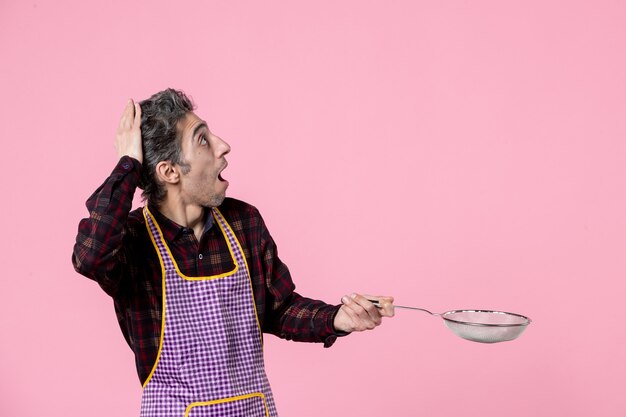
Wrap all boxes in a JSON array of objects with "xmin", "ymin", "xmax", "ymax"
[{"xmin": 370, "ymin": 300, "xmax": 531, "ymax": 343}]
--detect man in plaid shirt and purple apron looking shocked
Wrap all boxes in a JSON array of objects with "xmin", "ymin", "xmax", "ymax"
[{"xmin": 72, "ymin": 89, "xmax": 393, "ymax": 417}]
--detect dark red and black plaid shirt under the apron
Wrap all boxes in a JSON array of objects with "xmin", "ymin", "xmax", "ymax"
[{"xmin": 72, "ymin": 156, "xmax": 341, "ymax": 383}]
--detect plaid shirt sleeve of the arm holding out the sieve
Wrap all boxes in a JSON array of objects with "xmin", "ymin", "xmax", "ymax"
[{"xmin": 260, "ymin": 213, "xmax": 348, "ymax": 347}]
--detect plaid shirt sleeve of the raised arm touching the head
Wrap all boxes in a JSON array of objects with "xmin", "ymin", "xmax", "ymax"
[{"xmin": 72, "ymin": 156, "xmax": 141, "ymax": 296}]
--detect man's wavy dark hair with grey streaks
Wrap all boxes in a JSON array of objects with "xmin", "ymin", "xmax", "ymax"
[{"xmin": 139, "ymin": 88, "xmax": 194, "ymax": 204}]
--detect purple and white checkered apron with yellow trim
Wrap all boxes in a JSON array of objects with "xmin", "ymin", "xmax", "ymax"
[{"xmin": 141, "ymin": 207, "xmax": 277, "ymax": 417}]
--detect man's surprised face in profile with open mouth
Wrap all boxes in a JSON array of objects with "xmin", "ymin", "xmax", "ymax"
[{"xmin": 178, "ymin": 112, "xmax": 230, "ymax": 207}]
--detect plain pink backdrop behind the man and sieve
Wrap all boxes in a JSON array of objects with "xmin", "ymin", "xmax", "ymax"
[{"xmin": 0, "ymin": 0, "xmax": 626, "ymax": 417}]
